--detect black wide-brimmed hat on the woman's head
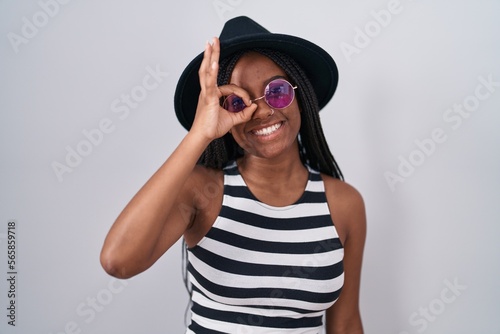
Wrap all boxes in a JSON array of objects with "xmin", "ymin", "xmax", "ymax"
[{"xmin": 174, "ymin": 16, "xmax": 338, "ymax": 130}]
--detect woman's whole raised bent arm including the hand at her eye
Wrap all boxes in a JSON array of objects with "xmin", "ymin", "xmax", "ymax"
[{"xmin": 100, "ymin": 39, "xmax": 255, "ymax": 278}]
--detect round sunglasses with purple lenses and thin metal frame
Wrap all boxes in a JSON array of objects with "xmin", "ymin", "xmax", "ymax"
[{"xmin": 222, "ymin": 79, "xmax": 297, "ymax": 112}]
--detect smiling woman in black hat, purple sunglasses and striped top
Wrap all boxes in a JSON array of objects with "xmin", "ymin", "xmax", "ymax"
[{"xmin": 101, "ymin": 17, "xmax": 366, "ymax": 334}]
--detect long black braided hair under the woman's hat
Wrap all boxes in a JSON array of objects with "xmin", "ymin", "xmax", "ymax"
[{"xmin": 198, "ymin": 48, "xmax": 344, "ymax": 180}]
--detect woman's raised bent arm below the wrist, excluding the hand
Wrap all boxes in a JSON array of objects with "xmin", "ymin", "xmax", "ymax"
[{"xmin": 100, "ymin": 134, "xmax": 210, "ymax": 278}]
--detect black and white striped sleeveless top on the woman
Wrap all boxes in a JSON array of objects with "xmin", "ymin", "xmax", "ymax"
[{"xmin": 186, "ymin": 162, "xmax": 344, "ymax": 334}]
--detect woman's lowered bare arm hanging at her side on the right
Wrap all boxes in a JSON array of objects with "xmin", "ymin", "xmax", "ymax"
[{"xmin": 325, "ymin": 179, "xmax": 366, "ymax": 334}]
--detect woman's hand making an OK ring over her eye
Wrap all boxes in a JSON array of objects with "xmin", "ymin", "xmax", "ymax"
[{"xmin": 191, "ymin": 37, "xmax": 257, "ymax": 141}]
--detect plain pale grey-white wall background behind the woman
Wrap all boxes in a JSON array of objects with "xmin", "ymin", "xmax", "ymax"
[{"xmin": 0, "ymin": 0, "xmax": 500, "ymax": 334}]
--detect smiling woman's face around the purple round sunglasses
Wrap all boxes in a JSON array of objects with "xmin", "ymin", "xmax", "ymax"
[{"xmin": 230, "ymin": 52, "xmax": 301, "ymax": 158}]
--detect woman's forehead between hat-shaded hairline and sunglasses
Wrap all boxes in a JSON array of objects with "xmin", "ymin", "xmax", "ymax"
[{"xmin": 231, "ymin": 51, "xmax": 286, "ymax": 85}]
